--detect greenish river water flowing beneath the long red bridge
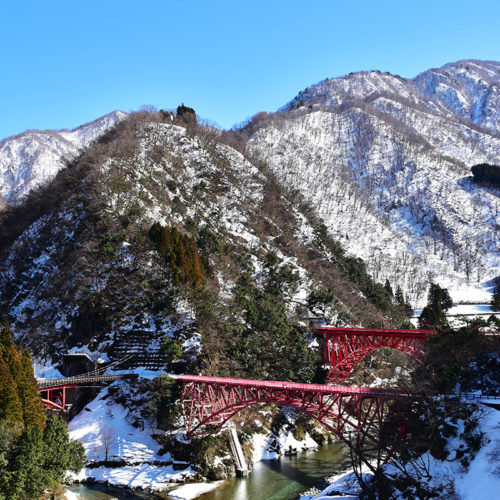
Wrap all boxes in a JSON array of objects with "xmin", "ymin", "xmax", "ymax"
[{"xmin": 69, "ymin": 443, "xmax": 348, "ymax": 500}]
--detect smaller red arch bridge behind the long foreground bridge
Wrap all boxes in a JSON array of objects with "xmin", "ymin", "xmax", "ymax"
[{"xmin": 313, "ymin": 326, "xmax": 436, "ymax": 381}]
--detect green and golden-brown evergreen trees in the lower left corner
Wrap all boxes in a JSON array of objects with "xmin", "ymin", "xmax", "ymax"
[{"xmin": 0, "ymin": 323, "xmax": 85, "ymax": 500}]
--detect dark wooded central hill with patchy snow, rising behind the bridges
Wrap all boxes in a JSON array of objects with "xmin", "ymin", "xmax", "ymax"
[{"xmin": 0, "ymin": 113, "xmax": 406, "ymax": 380}]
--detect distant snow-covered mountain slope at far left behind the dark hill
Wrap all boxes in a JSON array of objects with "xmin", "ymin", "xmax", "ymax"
[{"xmin": 0, "ymin": 111, "xmax": 126, "ymax": 205}]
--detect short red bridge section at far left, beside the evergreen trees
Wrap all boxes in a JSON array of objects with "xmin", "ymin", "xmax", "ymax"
[{"xmin": 38, "ymin": 373, "xmax": 128, "ymax": 411}]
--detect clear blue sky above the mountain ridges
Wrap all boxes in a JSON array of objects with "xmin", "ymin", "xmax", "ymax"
[{"xmin": 0, "ymin": 0, "xmax": 500, "ymax": 138}]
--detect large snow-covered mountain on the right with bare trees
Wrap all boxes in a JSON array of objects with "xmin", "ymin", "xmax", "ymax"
[{"xmin": 248, "ymin": 61, "xmax": 500, "ymax": 303}]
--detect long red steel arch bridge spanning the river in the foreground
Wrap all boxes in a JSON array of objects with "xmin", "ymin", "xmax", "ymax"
[{"xmin": 173, "ymin": 375, "xmax": 421, "ymax": 466}]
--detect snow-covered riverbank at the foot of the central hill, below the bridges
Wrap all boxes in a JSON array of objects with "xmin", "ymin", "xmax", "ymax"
[{"xmin": 68, "ymin": 382, "xmax": 324, "ymax": 499}]
